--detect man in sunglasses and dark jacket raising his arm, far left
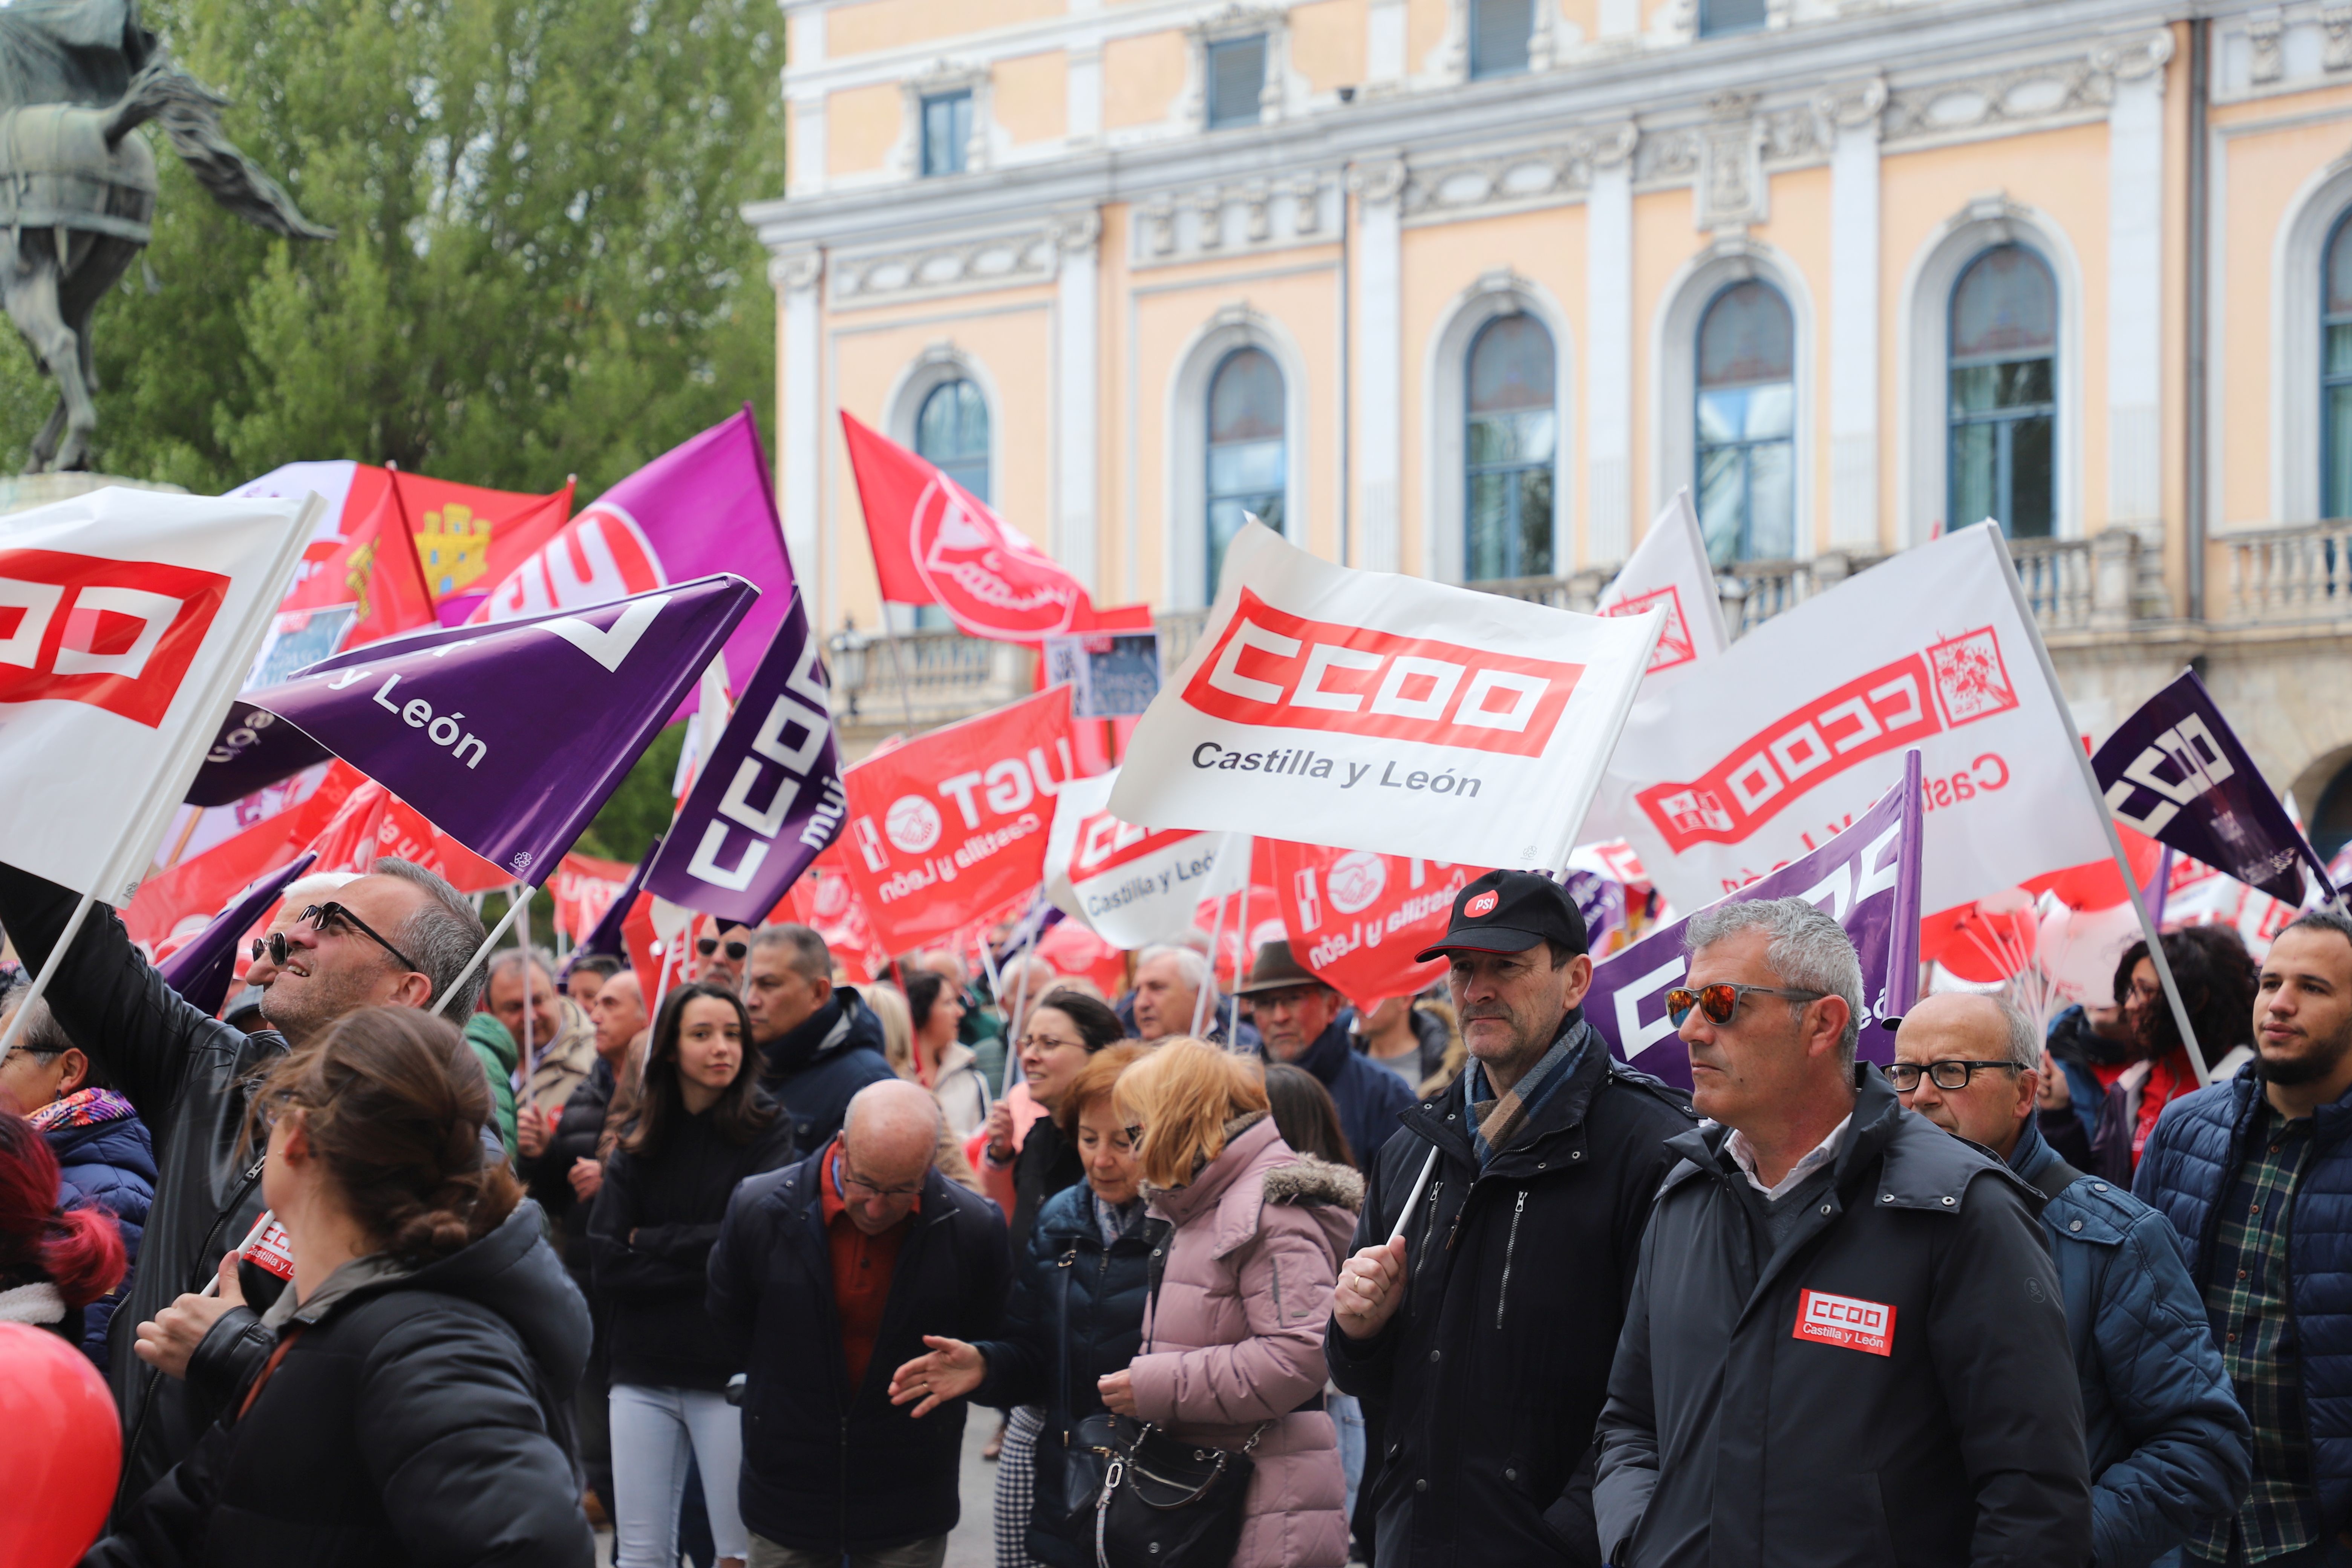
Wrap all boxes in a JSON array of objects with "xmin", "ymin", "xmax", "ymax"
[{"xmin": 0, "ymin": 858, "xmax": 489, "ymax": 1498}]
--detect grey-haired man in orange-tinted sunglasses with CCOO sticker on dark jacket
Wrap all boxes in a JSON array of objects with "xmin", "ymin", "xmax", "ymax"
[{"xmin": 1595, "ymin": 898, "xmax": 2091, "ymax": 1568}]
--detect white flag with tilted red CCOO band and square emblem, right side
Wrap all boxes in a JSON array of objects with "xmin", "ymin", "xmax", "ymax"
[{"xmin": 1604, "ymin": 524, "xmax": 2110, "ymax": 912}]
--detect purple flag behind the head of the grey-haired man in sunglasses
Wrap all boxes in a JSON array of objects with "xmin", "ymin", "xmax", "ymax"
[{"xmin": 1585, "ymin": 752, "xmax": 1919, "ymax": 1089}]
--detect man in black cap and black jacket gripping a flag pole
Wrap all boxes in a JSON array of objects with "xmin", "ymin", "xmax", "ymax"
[{"xmin": 1324, "ymin": 872, "xmax": 1694, "ymax": 1568}]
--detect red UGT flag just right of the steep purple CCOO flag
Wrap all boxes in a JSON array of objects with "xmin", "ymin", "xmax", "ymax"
[{"xmin": 842, "ymin": 686, "xmax": 1070, "ymax": 952}]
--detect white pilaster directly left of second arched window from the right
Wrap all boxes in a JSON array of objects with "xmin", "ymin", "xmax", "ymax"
[{"xmin": 1813, "ymin": 78, "xmax": 1886, "ymax": 550}]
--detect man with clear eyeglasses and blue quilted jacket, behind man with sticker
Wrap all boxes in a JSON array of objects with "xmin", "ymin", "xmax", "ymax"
[{"xmin": 1886, "ymin": 994, "xmax": 2251, "ymax": 1568}]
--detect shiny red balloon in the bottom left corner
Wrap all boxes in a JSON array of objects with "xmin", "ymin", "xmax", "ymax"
[{"xmin": 0, "ymin": 1323, "xmax": 122, "ymax": 1568}]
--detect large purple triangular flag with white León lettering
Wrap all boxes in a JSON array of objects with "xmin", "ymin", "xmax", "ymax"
[{"xmin": 247, "ymin": 576, "xmax": 760, "ymax": 886}]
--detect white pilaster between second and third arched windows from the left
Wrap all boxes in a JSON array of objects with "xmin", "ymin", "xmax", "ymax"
[{"xmin": 1355, "ymin": 158, "xmax": 1404, "ymax": 571}]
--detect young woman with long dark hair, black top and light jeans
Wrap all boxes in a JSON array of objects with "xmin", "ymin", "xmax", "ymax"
[{"xmin": 588, "ymin": 980, "xmax": 793, "ymax": 1568}]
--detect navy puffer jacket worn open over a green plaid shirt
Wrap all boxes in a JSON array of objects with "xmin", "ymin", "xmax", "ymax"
[{"xmin": 2131, "ymin": 1063, "xmax": 2352, "ymax": 1535}]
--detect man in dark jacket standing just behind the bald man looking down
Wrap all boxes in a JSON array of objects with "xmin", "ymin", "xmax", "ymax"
[{"xmin": 743, "ymin": 926, "xmax": 899, "ymax": 1150}]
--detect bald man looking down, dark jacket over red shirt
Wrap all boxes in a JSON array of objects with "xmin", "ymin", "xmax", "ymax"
[{"xmin": 708, "ymin": 1076, "xmax": 1011, "ymax": 1568}]
